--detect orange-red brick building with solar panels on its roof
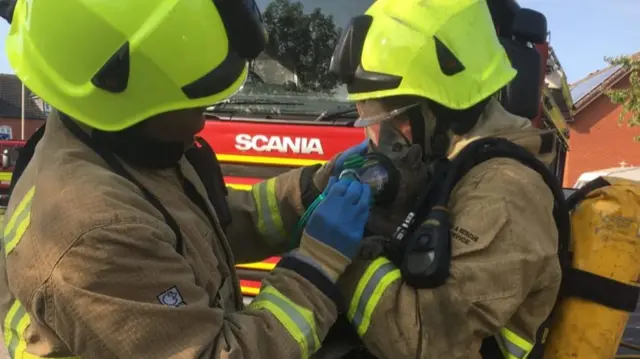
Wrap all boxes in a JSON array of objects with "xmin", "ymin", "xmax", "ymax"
[{"xmin": 563, "ymin": 60, "xmax": 640, "ymax": 187}]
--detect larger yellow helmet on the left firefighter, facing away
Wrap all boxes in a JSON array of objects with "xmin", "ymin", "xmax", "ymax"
[{"xmin": 6, "ymin": 0, "xmax": 267, "ymax": 131}]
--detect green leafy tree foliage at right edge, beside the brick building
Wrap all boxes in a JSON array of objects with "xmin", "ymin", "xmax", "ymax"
[{"xmin": 605, "ymin": 56, "xmax": 640, "ymax": 142}]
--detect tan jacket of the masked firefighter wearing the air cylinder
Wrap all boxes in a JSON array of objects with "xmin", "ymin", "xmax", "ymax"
[{"xmin": 340, "ymin": 101, "xmax": 561, "ymax": 359}]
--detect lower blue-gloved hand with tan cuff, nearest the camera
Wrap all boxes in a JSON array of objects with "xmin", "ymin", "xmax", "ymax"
[{"xmin": 300, "ymin": 177, "xmax": 371, "ymax": 280}]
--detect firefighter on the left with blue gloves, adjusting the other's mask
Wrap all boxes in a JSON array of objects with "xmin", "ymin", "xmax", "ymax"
[{"xmin": 0, "ymin": 0, "xmax": 370, "ymax": 359}]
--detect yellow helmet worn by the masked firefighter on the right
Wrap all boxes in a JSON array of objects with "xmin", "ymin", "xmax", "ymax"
[{"xmin": 331, "ymin": 0, "xmax": 516, "ymax": 110}]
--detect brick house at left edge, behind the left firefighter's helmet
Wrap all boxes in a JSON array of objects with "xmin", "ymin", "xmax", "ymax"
[{"xmin": 0, "ymin": 74, "xmax": 48, "ymax": 140}]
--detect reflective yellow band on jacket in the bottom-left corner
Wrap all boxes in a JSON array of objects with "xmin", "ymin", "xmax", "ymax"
[{"xmin": 3, "ymin": 300, "xmax": 80, "ymax": 359}]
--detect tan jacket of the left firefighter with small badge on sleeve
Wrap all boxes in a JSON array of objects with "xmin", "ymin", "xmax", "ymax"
[{"xmin": 0, "ymin": 111, "xmax": 346, "ymax": 359}]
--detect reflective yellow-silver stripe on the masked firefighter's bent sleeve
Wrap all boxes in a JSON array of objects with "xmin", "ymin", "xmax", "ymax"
[{"xmin": 347, "ymin": 257, "xmax": 400, "ymax": 337}]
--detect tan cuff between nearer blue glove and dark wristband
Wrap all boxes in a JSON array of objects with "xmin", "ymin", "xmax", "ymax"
[{"xmin": 300, "ymin": 232, "xmax": 351, "ymax": 282}]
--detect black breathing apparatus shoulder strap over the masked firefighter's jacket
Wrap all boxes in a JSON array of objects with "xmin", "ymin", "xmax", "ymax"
[{"xmin": 390, "ymin": 133, "xmax": 570, "ymax": 294}]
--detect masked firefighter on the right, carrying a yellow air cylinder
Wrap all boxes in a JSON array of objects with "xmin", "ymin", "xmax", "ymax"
[{"xmin": 316, "ymin": 0, "xmax": 561, "ymax": 359}]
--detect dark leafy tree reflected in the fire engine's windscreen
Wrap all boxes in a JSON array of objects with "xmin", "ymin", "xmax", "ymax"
[{"xmin": 263, "ymin": 0, "xmax": 341, "ymax": 91}]
